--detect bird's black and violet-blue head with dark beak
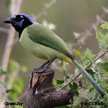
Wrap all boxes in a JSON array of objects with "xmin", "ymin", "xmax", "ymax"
[{"xmin": 4, "ymin": 14, "xmax": 36, "ymax": 35}]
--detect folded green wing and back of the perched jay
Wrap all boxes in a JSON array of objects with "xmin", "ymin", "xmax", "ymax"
[{"xmin": 27, "ymin": 24, "xmax": 72, "ymax": 56}]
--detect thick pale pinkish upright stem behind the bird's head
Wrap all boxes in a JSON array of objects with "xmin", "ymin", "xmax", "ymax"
[{"xmin": 1, "ymin": 0, "xmax": 22, "ymax": 81}]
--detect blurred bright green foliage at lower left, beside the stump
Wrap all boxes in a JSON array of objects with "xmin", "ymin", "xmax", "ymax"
[{"xmin": 0, "ymin": 60, "xmax": 27, "ymax": 108}]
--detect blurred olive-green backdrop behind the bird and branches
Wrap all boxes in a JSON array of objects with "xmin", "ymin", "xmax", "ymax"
[{"xmin": 0, "ymin": 0, "xmax": 108, "ymax": 89}]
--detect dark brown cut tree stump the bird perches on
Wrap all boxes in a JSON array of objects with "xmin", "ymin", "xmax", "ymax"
[{"xmin": 22, "ymin": 67, "xmax": 73, "ymax": 108}]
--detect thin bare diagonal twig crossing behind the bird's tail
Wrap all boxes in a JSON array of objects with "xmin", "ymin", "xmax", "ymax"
[{"xmin": 60, "ymin": 50, "xmax": 108, "ymax": 90}]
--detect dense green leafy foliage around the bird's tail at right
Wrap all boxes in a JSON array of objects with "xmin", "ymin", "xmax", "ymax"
[{"xmin": 54, "ymin": 27, "xmax": 108, "ymax": 108}]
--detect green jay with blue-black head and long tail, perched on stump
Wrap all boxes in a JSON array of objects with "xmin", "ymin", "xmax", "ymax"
[{"xmin": 4, "ymin": 13, "xmax": 105, "ymax": 97}]
